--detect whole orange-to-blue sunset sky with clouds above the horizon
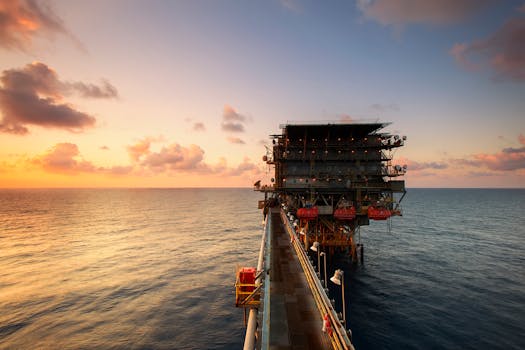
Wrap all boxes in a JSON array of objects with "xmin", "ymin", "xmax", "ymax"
[{"xmin": 0, "ymin": 0, "xmax": 525, "ymax": 188}]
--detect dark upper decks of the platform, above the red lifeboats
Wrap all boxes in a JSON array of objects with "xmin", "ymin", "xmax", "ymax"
[{"xmin": 268, "ymin": 123, "xmax": 405, "ymax": 192}]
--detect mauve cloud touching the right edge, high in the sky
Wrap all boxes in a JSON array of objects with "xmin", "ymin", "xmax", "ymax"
[{"xmin": 450, "ymin": 17, "xmax": 525, "ymax": 82}]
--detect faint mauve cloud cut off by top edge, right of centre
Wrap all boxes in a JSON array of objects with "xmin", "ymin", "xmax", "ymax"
[{"xmin": 357, "ymin": 0, "xmax": 494, "ymax": 27}]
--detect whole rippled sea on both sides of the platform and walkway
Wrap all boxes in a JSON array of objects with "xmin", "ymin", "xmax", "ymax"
[{"xmin": 0, "ymin": 189, "xmax": 525, "ymax": 350}]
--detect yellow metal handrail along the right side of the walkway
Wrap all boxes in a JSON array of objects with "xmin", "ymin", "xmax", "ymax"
[{"xmin": 281, "ymin": 209, "xmax": 354, "ymax": 350}]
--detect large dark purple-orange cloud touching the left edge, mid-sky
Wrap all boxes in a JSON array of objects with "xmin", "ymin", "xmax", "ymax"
[{"xmin": 0, "ymin": 62, "xmax": 117, "ymax": 135}]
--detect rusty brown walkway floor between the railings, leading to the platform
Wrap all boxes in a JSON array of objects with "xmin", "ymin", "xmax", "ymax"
[{"xmin": 270, "ymin": 211, "xmax": 331, "ymax": 350}]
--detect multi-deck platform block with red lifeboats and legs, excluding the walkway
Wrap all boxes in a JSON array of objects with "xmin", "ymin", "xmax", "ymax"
[{"xmin": 256, "ymin": 123, "xmax": 407, "ymax": 261}]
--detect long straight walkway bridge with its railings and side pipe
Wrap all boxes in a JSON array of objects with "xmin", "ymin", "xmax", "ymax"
[{"xmin": 239, "ymin": 208, "xmax": 354, "ymax": 350}]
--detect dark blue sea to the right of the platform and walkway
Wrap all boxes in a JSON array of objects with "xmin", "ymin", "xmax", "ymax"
[{"xmin": 342, "ymin": 189, "xmax": 525, "ymax": 349}]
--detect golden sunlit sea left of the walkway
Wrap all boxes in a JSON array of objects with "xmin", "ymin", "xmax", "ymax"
[{"xmin": 0, "ymin": 189, "xmax": 262, "ymax": 349}]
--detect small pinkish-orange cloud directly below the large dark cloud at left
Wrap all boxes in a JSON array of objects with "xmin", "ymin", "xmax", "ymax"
[{"xmin": 32, "ymin": 142, "xmax": 96, "ymax": 174}]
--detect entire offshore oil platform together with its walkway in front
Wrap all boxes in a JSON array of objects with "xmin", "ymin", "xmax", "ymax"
[{"xmin": 235, "ymin": 122, "xmax": 407, "ymax": 349}]
